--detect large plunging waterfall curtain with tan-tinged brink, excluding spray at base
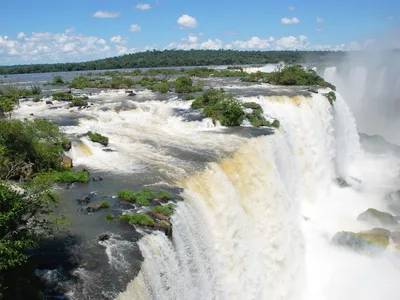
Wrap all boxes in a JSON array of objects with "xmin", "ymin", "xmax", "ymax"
[{"xmin": 118, "ymin": 94, "xmax": 382, "ymax": 300}]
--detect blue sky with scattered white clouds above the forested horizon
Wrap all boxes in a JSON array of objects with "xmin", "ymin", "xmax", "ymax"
[{"xmin": 0, "ymin": 0, "xmax": 400, "ymax": 65}]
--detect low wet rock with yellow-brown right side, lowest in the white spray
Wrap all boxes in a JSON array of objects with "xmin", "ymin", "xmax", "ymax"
[{"xmin": 332, "ymin": 231, "xmax": 389, "ymax": 254}]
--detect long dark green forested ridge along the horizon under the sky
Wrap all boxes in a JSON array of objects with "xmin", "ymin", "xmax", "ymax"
[{"xmin": 0, "ymin": 50, "xmax": 345, "ymax": 75}]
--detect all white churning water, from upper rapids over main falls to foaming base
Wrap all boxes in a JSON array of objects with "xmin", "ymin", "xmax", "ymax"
[{"xmin": 8, "ymin": 71, "xmax": 400, "ymax": 300}]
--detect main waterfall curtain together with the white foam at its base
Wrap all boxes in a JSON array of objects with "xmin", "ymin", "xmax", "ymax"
[{"xmin": 118, "ymin": 95, "xmax": 400, "ymax": 300}]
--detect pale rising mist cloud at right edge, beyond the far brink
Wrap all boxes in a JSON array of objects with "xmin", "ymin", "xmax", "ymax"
[{"xmin": 323, "ymin": 45, "xmax": 400, "ymax": 145}]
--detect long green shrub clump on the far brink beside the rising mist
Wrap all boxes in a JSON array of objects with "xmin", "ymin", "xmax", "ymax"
[{"xmin": 243, "ymin": 65, "xmax": 336, "ymax": 90}]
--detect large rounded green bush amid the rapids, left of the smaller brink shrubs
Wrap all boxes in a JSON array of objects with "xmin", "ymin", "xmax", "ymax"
[{"xmin": 192, "ymin": 89, "xmax": 245, "ymax": 126}]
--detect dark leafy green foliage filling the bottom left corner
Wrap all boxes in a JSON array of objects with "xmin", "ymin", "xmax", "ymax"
[{"xmin": 0, "ymin": 176, "xmax": 68, "ymax": 299}]
